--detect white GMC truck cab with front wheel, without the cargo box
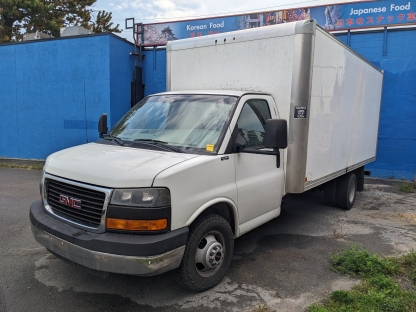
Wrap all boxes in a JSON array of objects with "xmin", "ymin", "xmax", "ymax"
[{"xmin": 30, "ymin": 90, "xmax": 287, "ymax": 291}]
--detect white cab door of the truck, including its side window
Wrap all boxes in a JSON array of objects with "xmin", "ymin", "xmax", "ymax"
[{"xmin": 235, "ymin": 96, "xmax": 284, "ymax": 234}]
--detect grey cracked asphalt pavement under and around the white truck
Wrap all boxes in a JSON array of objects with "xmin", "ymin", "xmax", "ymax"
[{"xmin": 0, "ymin": 168, "xmax": 416, "ymax": 312}]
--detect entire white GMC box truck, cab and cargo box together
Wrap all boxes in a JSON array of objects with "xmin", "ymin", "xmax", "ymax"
[{"xmin": 30, "ymin": 20, "xmax": 383, "ymax": 291}]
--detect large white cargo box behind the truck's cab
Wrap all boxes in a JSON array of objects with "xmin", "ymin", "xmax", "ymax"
[{"xmin": 167, "ymin": 20, "xmax": 383, "ymax": 193}]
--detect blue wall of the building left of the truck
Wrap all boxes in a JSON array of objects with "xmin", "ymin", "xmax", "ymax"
[{"xmin": 0, "ymin": 34, "xmax": 133, "ymax": 159}]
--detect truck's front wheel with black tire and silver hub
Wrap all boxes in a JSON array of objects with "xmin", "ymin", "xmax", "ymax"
[{"xmin": 179, "ymin": 214, "xmax": 234, "ymax": 291}]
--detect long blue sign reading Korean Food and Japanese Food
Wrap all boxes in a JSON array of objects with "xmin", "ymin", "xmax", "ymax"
[{"xmin": 143, "ymin": 0, "xmax": 416, "ymax": 46}]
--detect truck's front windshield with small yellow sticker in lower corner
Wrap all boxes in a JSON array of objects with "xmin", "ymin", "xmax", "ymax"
[{"xmin": 109, "ymin": 95, "xmax": 237, "ymax": 152}]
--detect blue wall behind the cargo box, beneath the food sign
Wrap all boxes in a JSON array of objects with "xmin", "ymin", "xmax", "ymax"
[{"xmin": 143, "ymin": 29, "xmax": 416, "ymax": 180}]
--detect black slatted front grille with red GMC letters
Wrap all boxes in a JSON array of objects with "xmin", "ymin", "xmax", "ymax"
[{"xmin": 45, "ymin": 179, "xmax": 105, "ymax": 228}]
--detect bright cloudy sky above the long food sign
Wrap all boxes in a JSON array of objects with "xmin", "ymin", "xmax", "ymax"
[{"xmin": 94, "ymin": 0, "xmax": 364, "ymax": 38}]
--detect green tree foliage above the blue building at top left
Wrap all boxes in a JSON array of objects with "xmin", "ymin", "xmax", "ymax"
[{"xmin": 0, "ymin": 0, "xmax": 121, "ymax": 42}]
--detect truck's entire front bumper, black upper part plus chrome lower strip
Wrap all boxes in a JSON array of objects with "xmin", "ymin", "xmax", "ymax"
[{"xmin": 30, "ymin": 201, "xmax": 189, "ymax": 276}]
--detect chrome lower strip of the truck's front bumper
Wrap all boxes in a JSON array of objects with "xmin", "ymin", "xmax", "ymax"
[{"xmin": 31, "ymin": 224, "xmax": 185, "ymax": 276}]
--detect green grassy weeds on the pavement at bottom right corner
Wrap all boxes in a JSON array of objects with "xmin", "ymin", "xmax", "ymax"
[{"xmin": 309, "ymin": 245, "xmax": 416, "ymax": 312}]
